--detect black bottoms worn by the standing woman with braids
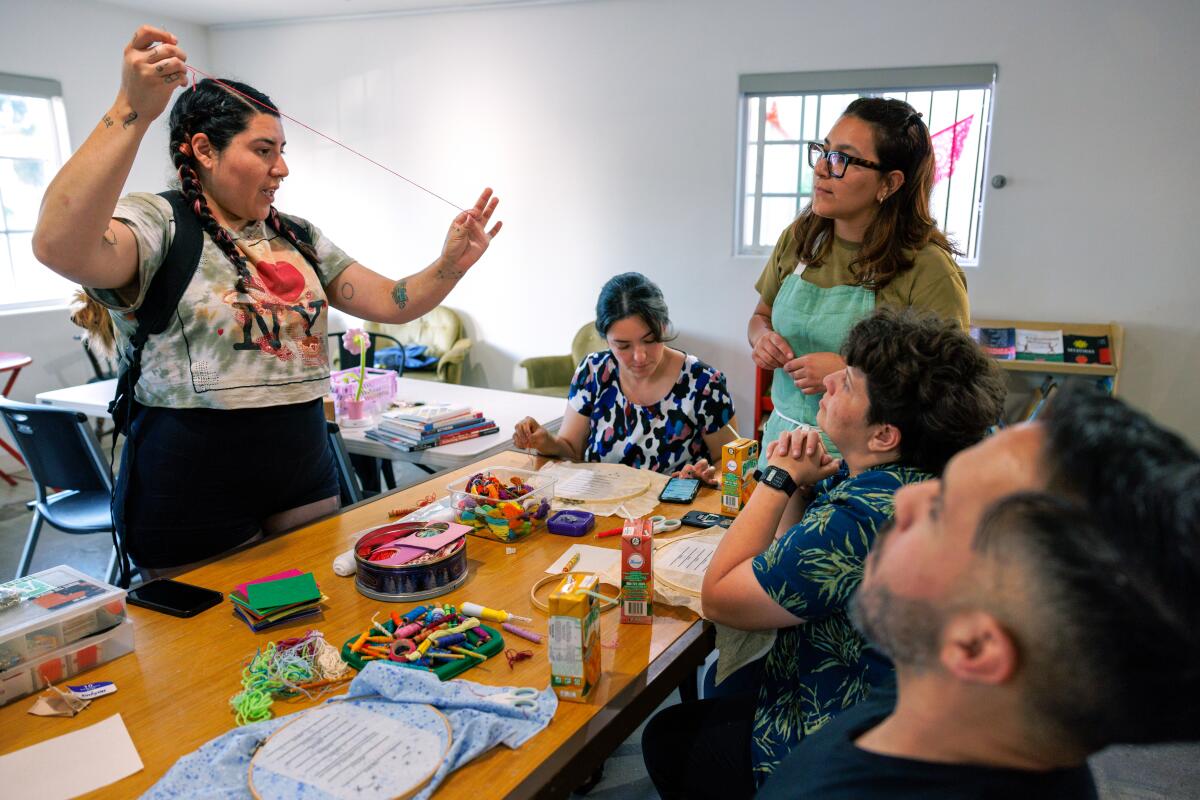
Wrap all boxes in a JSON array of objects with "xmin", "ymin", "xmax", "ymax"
[{"xmin": 114, "ymin": 399, "xmax": 338, "ymax": 569}]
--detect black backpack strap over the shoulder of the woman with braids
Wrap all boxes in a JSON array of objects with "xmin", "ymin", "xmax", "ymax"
[{"xmin": 108, "ymin": 190, "xmax": 204, "ymax": 435}]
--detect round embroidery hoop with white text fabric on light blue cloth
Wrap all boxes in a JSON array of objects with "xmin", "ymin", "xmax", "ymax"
[{"xmin": 247, "ymin": 694, "xmax": 454, "ymax": 800}]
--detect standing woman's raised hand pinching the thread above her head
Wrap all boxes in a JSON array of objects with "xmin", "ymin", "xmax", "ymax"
[{"xmin": 121, "ymin": 25, "xmax": 187, "ymax": 127}]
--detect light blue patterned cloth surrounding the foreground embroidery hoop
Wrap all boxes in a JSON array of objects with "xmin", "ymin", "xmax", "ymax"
[{"xmin": 142, "ymin": 662, "xmax": 558, "ymax": 800}]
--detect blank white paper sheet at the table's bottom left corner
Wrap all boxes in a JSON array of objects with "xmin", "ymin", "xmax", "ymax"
[{"xmin": 0, "ymin": 714, "xmax": 143, "ymax": 800}]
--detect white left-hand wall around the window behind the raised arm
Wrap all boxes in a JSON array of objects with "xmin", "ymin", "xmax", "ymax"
[{"xmin": 0, "ymin": 0, "xmax": 208, "ymax": 470}]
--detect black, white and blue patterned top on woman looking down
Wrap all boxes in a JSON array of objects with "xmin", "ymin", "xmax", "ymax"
[{"xmin": 566, "ymin": 350, "xmax": 733, "ymax": 475}]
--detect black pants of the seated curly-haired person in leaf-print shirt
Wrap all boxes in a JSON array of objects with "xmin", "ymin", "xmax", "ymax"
[{"xmin": 642, "ymin": 694, "xmax": 755, "ymax": 800}]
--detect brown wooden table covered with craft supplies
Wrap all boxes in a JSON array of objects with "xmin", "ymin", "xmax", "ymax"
[{"xmin": 0, "ymin": 451, "xmax": 720, "ymax": 800}]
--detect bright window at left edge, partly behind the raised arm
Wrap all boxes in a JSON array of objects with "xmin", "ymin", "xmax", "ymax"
[{"xmin": 0, "ymin": 73, "xmax": 74, "ymax": 308}]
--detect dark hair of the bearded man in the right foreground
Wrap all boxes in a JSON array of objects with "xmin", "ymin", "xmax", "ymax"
[{"xmin": 1008, "ymin": 387, "xmax": 1200, "ymax": 750}]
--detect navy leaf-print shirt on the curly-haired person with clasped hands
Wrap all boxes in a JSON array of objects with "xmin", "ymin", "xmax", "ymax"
[{"xmin": 750, "ymin": 464, "xmax": 932, "ymax": 784}]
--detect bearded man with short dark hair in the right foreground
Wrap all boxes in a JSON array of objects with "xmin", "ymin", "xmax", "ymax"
[{"xmin": 757, "ymin": 381, "xmax": 1200, "ymax": 800}]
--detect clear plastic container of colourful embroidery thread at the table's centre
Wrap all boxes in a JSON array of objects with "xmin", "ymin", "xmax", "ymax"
[{"xmin": 446, "ymin": 467, "xmax": 554, "ymax": 542}]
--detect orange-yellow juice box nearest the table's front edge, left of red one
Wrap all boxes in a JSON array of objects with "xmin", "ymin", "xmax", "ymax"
[{"xmin": 550, "ymin": 575, "xmax": 600, "ymax": 703}]
